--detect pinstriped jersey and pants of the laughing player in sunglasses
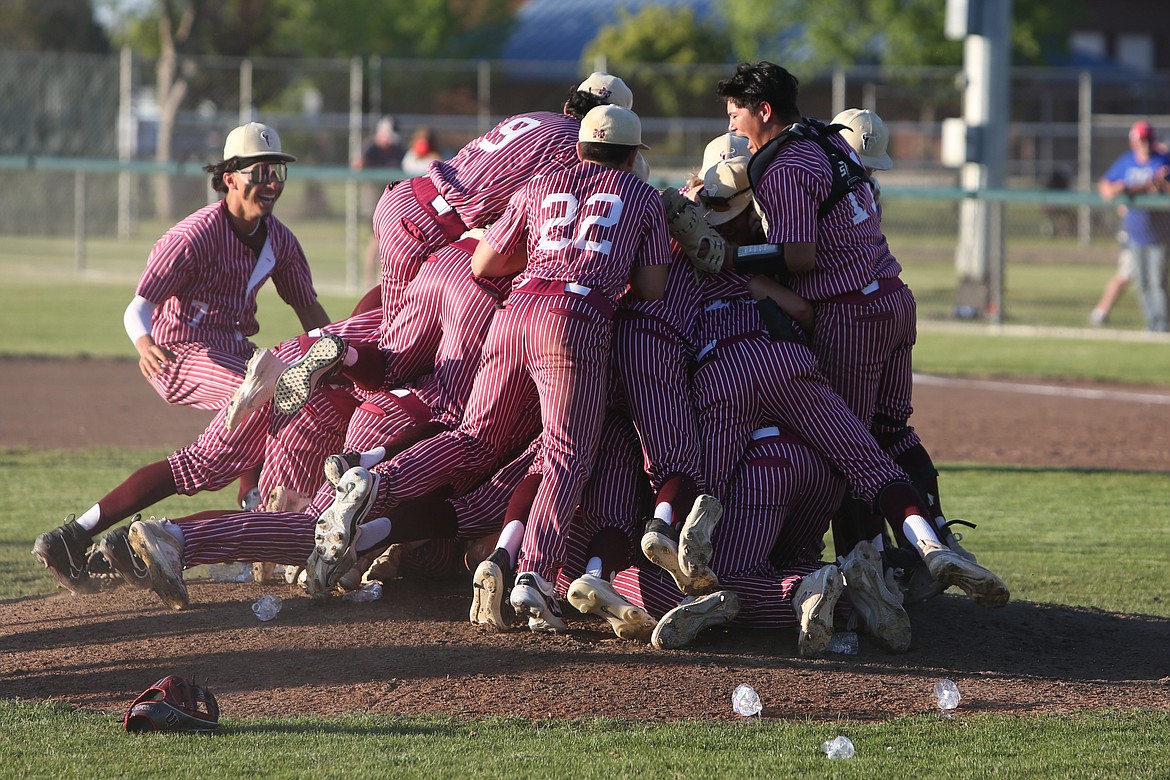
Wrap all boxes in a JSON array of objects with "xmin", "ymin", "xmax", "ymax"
[{"xmin": 136, "ymin": 201, "xmax": 317, "ymax": 409}]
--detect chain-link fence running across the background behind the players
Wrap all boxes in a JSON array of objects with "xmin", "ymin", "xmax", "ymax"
[{"xmin": 0, "ymin": 53, "xmax": 1170, "ymax": 327}]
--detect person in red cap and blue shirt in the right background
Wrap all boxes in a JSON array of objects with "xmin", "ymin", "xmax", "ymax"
[{"xmin": 1097, "ymin": 119, "xmax": 1170, "ymax": 332}]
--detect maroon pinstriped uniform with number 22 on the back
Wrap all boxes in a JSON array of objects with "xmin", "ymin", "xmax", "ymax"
[{"xmin": 377, "ymin": 163, "xmax": 669, "ymax": 579}]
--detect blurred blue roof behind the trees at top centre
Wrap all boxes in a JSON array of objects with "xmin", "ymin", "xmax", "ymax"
[{"xmin": 500, "ymin": 0, "xmax": 716, "ymax": 62}]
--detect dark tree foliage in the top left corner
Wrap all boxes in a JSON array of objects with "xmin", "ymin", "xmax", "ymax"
[{"xmin": 0, "ymin": 0, "xmax": 110, "ymax": 54}]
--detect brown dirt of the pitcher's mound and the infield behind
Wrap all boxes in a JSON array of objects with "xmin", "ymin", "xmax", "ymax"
[{"xmin": 0, "ymin": 359, "xmax": 1170, "ymax": 720}]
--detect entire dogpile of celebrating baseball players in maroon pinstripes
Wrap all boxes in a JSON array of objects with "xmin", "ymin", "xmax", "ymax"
[{"xmin": 33, "ymin": 62, "xmax": 1009, "ymax": 657}]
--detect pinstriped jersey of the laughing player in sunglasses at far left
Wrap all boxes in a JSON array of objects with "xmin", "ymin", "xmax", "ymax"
[{"xmin": 137, "ymin": 201, "xmax": 317, "ymax": 357}]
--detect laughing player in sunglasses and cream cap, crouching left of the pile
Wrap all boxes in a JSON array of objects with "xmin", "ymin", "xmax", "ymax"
[{"xmin": 124, "ymin": 122, "xmax": 329, "ymax": 409}]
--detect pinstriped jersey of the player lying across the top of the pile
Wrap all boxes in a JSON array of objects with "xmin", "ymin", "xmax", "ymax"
[{"xmin": 427, "ymin": 111, "xmax": 580, "ymax": 228}]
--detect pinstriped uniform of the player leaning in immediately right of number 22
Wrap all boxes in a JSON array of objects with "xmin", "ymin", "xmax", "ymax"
[{"xmin": 613, "ymin": 241, "xmax": 706, "ymax": 493}]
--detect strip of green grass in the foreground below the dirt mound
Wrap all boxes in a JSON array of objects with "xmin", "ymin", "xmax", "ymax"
[{"xmin": 0, "ymin": 702, "xmax": 1170, "ymax": 780}]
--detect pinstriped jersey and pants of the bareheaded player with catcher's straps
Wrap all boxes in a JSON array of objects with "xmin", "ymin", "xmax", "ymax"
[{"xmin": 755, "ymin": 130, "xmax": 918, "ymax": 448}]
